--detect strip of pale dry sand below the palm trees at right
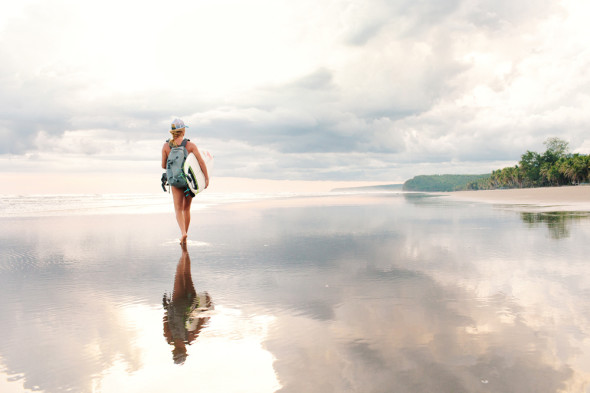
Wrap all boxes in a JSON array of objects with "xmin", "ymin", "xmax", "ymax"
[{"xmin": 444, "ymin": 185, "xmax": 590, "ymax": 211}]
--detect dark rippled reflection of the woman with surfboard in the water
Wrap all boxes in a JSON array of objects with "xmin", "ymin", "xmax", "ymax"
[{"xmin": 163, "ymin": 244, "xmax": 213, "ymax": 364}]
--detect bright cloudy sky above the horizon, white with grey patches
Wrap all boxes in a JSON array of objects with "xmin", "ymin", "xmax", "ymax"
[{"xmin": 0, "ymin": 0, "xmax": 590, "ymax": 193}]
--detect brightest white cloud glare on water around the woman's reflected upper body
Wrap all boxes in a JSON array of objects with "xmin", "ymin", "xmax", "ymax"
[{"xmin": 99, "ymin": 306, "xmax": 280, "ymax": 393}]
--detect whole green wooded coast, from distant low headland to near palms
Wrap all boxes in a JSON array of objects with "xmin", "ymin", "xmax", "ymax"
[{"xmin": 403, "ymin": 138, "xmax": 590, "ymax": 191}]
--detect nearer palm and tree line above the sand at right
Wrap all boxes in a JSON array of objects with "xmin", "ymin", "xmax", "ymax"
[{"xmin": 465, "ymin": 138, "xmax": 590, "ymax": 190}]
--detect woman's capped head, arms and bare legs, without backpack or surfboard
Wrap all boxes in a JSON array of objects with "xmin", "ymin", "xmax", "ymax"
[{"xmin": 162, "ymin": 119, "xmax": 209, "ymax": 244}]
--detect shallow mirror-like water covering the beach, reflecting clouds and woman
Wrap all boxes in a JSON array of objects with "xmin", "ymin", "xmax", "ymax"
[{"xmin": 0, "ymin": 194, "xmax": 590, "ymax": 393}]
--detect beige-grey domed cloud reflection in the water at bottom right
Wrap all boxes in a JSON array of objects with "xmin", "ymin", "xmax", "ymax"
[{"xmin": 268, "ymin": 273, "xmax": 572, "ymax": 392}]
